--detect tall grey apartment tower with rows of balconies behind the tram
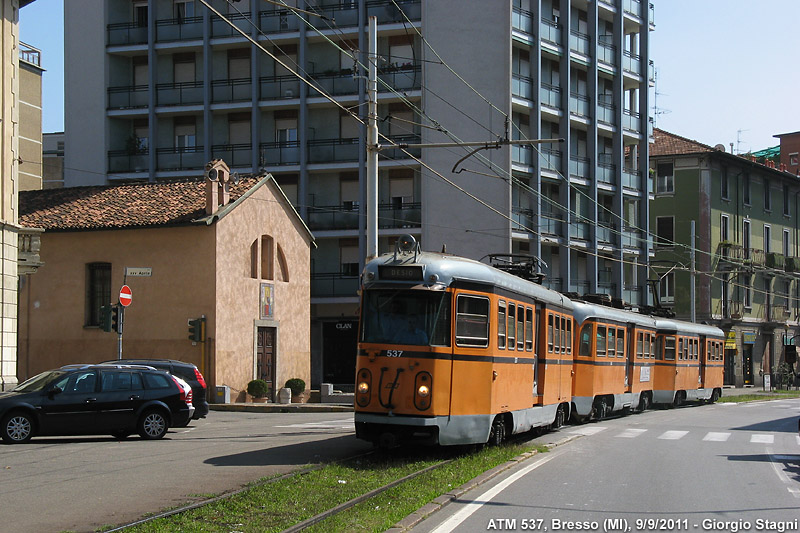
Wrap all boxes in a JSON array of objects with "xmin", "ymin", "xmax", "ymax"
[{"xmin": 64, "ymin": 0, "xmax": 653, "ymax": 385}]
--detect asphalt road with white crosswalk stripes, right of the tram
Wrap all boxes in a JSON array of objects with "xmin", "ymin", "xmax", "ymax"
[{"xmin": 414, "ymin": 400, "xmax": 800, "ymax": 533}]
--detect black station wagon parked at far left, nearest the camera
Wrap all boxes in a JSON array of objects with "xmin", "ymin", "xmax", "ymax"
[{"xmin": 0, "ymin": 365, "xmax": 191, "ymax": 443}]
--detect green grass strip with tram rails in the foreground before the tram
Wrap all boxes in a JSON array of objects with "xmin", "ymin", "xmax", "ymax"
[{"xmin": 114, "ymin": 444, "xmax": 537, "ymax": 533}]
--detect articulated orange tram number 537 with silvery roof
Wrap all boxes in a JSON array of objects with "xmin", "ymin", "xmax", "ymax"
[{"xmin": 355, "ymin": 236, "xmax": 724, "ymax": 447}]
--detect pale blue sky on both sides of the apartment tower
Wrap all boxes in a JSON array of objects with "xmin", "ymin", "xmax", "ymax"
[{"xmin": 20, "ymin": 0, "xmax": 800, "ymax": 152}]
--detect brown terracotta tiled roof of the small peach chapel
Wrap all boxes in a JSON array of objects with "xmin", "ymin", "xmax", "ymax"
[{"xmin": 19, "ymin": 177, "xmax": 259, "ymax": 230}]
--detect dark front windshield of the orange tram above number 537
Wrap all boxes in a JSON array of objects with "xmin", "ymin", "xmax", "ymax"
[{"xmin": 361, "ymin": 289, "xmax": 450, "ymax": 346}]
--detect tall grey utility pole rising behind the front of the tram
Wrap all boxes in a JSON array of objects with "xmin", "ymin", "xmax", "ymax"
[{"xmin": 367, "ymin": 16, "xmax": 380, "ymax": 261}]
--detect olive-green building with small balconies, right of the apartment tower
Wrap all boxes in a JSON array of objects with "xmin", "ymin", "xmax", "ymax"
[{"xmin": 650, "ymin": 129, "xmax": 800, "ymax": 387}]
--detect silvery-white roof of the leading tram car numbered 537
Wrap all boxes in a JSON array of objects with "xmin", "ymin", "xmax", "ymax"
[{"xmin": 363, "ymin": 252, "xmax": 572, "ymax": 309}]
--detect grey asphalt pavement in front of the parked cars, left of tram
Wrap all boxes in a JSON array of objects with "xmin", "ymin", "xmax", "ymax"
[{"xmin": 0, "ymin": 411, "xmax": 371, "ymax": 533}]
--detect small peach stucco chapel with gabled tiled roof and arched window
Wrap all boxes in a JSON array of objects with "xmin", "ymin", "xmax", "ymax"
[{"xmin": 19, "ymin": 166, "xmax": 314, "ymax": 401}]
